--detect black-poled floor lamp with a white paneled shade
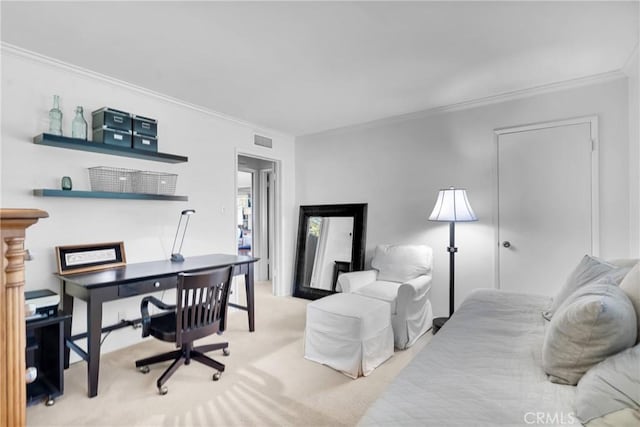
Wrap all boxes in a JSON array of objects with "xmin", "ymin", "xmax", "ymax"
[{"xmin": 429, "ymin": 187, "xmax": 478, "ymax": 334}]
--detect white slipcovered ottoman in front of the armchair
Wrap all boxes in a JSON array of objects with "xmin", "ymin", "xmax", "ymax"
[{"xmin": 304, "ymin": 293, "xmax": 393, "ymax": 378}]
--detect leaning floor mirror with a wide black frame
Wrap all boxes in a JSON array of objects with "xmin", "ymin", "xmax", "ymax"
[{"xmin": 293, "ymin": 203, "xmax": 367, "ymax": 299}]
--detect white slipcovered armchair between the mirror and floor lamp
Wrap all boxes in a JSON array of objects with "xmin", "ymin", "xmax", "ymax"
[{"xmin": 336, "ymin": 245, "xmax": 433, "ymax": 349}]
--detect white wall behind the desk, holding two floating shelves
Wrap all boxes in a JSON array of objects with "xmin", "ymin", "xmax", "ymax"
[{"xmin": 0, "ymin": 46, "xmax": 295, "ymax": 351}]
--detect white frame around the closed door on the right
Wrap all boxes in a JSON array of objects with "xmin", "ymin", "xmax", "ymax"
[{"xmin": 493, "ymin": 115, "xmax": 600, "ymax": 289}]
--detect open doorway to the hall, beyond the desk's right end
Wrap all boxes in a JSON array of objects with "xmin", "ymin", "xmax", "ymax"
[{"xmin": 236, "ymin": 154, "xmax": 276, "ymax": 282}]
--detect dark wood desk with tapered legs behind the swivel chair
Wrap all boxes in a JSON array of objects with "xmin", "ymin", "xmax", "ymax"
[{"xmin": 58, "ymin": 254, "xmax": 258, "ymax": 397}]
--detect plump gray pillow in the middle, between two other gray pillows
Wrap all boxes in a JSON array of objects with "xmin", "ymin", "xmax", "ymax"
[{"xmin": 542, "ymin": 278, "xmax": 637, "ymax": 385}]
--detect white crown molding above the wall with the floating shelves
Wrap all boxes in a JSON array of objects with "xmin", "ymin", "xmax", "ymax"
[{"xmin": 0, "ymin": 41, "xmax": 293, "ymax": 138}]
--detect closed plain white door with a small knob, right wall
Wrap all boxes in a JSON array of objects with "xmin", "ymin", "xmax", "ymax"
[{"xmin": 496, "ymin": 117, "xmax": 598, "ymax": 296}]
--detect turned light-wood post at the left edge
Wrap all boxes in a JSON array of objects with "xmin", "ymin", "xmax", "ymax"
[{"xmin": 0, "ymin": 209, "xmax": 49, "ymax": 427}]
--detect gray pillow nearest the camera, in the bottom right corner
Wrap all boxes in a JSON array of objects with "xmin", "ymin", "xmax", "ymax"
[{"xmin": 576, "ymin": 345, "xmax": 640, "ymax": 423}]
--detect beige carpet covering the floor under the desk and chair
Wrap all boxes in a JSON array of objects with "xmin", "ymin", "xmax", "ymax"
[{"xmin": 27, "ymin": 282, "xmax": 431, "ymax": 427}]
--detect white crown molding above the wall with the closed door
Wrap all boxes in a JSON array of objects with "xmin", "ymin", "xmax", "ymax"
[{"xmin": 296, "ymin": 70, "xmax": 627, "ymax": 138}]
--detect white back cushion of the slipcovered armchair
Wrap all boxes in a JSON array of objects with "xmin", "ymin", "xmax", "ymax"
[{"xmin": 371, "ymin": 245, "xmax": 433, "ymax": 283}]
